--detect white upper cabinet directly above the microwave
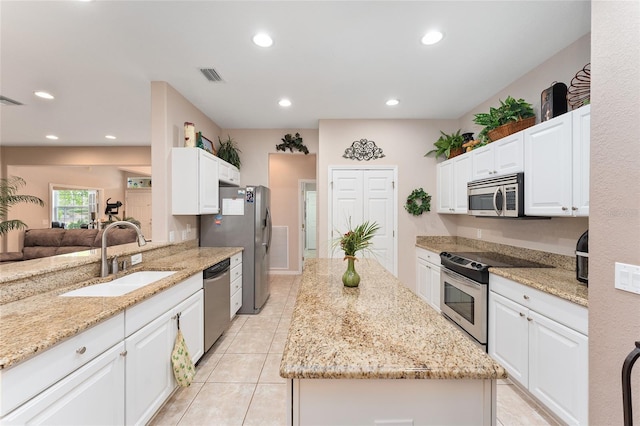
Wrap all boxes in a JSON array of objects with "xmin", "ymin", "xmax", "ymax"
[{"xmin": 471, "ymin": 131, "xmax": 524, "ymax": 180}]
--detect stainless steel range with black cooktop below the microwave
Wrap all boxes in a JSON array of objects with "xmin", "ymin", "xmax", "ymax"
[{"xmin": 440, "ymin": 252, "xmax": 551, "ymax": 351}]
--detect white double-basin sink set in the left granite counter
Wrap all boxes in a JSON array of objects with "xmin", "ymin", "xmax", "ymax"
[{"xmin": 60, "ymin": 271, "xmax": 176, "ymax": 297}]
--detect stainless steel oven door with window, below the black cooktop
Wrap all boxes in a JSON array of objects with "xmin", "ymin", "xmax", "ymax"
[{"xmin": 440, "ymin": 267, "xmax": 489, "ymax": 350}]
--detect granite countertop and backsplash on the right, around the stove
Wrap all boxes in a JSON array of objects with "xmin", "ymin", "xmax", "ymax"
[{"xmin": 416, "ymin": 236, "xmax": 589, "ymax": 307}]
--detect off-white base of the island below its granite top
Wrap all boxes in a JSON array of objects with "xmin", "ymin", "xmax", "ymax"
[{"xmin": 287, "ymin": 379, "xmax": 496, "ymax": 426}]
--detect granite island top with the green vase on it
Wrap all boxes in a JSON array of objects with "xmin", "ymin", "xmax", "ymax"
[{"xmin": 280, "ymin": 259, "xmax": 507, "ymax": 379}]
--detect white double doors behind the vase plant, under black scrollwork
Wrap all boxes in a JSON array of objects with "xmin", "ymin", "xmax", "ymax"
[{"xmin": 329, "ymin": 168, "xmax": 397, "ymax": 274}]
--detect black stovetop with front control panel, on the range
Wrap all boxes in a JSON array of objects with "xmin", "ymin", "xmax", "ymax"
[{"xmin": 440, "ymin": 252, "xmax": 552, "ymax": 284}]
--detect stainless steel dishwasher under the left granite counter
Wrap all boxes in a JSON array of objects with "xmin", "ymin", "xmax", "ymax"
[{"xmin": 203, "ymin": 259, "xmax": 231, "ymax": 352}]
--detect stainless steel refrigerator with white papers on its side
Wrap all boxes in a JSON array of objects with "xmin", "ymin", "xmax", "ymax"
[{"xmin": 200, "ymin": 186, "xmax": 271, "ymax": 314}]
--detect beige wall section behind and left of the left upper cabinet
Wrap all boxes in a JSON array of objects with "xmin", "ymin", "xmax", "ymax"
[{"xmin": 151, "ymin": 81, "xmax": 220, "ymax": 241}]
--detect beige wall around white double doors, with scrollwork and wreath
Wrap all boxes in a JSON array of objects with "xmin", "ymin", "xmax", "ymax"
[{"xmin": 317, "ymin": 120, "xmax": 458, "ymax": 288}]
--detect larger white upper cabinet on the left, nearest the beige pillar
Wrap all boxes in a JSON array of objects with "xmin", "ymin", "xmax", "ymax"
[{"xmin": 171, "ymin": 148, "xmax": 220, "ymax": 215}]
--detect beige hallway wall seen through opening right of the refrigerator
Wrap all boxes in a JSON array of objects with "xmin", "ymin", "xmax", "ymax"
[{"xmin": 269, "ymin": 153, "xmax": 317, "ymax": 272}]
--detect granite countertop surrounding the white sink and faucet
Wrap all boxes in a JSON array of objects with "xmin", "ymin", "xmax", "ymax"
[{"xmin": 0, "ymin": 247, "xmax": 242, "ymax": 369}]
